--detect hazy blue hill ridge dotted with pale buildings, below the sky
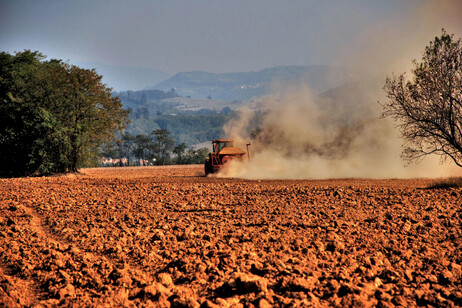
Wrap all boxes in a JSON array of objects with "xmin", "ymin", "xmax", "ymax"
[{"xmin": 150, "ymin": 65, "xmax": 352, "ymax": 101}]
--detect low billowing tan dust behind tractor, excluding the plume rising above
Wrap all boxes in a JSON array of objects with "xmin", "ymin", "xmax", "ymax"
[{"xmin": 219, "ymin": 85, "xmax": 460, "ymax": 179}]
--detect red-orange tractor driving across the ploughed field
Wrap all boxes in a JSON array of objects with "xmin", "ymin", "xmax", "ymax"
[{"xmin": 204, "ymin": 139, "xmax": 250, "ymax": 175}]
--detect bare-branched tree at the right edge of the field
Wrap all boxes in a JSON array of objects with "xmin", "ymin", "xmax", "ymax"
[{"xmin": 382, "ymin": 29, "xmax": 462, "ymax": 167}]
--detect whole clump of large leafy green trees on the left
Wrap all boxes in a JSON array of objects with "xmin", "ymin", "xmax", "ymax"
[{"xmin": 0, "ymin": 50, "xmax": 128, "ymax": 177}]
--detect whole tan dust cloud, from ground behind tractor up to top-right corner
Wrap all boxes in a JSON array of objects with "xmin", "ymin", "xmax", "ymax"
[{"xmin": 218, "ymin": 0, "xmax": 462, "ymax": 179}]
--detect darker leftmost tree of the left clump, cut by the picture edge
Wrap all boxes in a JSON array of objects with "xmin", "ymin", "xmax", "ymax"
[{"xmin": 0, "ymin": 51, "xmax": 66, "ymax": 176}]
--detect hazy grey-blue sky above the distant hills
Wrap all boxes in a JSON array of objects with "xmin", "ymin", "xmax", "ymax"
[{"xmin": 0, "ymin": 0, "xmax": 462, "ymax": 73}]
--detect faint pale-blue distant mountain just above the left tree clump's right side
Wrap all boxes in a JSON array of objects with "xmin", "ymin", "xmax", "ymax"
[{"xmin": 72, "ymin": 62, "xmax": 171, "ymax": 91}]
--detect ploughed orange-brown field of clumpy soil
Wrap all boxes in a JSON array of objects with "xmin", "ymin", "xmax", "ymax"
[{"xmin": 0, "ymin": 166, "xmax": 462, "ymax": 307}]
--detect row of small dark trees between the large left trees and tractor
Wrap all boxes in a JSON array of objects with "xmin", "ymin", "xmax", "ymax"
[{"xmin": 102, "ymin": 129, "xmax": 209, "ymax": 166}]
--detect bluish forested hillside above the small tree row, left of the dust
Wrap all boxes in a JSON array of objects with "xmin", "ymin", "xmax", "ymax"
[{"xmin": 113, "ymin": 89, "xmax": 241, "ymax": 146}]
